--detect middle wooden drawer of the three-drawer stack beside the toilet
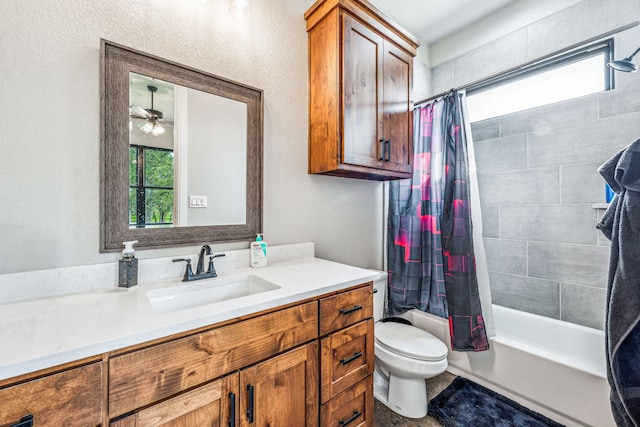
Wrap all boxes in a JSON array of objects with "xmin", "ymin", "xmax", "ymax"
[{"xmin": 320, "ymin": 319, "xmax": 374, "ymax": 403}]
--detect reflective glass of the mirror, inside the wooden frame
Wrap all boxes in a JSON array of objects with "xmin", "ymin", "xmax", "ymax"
[{"xmin": 128, "ymin": 72, "xmax": 247, "ymax": 228}]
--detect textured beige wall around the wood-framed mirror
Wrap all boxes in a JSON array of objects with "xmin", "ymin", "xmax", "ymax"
[{"xmin": 0, "ymin": 0, "xmax": 384, "ymax": 274}]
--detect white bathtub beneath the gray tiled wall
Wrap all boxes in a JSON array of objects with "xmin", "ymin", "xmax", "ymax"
[{"xmin": 403, "ymin": 305, "xmax": 615, "ymax": 427}]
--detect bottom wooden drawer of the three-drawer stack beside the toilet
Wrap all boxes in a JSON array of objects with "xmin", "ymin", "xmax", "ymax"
[{"xmin": 320, "ymin": 375, "xmax": 373, "ymax": 427}]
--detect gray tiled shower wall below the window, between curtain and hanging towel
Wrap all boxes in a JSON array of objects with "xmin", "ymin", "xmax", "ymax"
[{"xmin": 472, "ymin": 90, "xmax": 640, "ymax": 328}]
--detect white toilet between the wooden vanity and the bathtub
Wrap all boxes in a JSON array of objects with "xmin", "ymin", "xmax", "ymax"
[{"xmin": 373, "ymin": 272, "xmax": 447, "ymax": 418}]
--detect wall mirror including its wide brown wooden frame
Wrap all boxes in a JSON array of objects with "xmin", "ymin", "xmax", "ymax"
[{"xmin": 100, "ymin": 40, "xmax": 263, "ymax": 252}]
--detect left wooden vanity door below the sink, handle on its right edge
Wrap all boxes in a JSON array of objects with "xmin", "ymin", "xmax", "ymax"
[{"xmin": 111, "ymin": 373, "xmax": 239, "ymax": 427}]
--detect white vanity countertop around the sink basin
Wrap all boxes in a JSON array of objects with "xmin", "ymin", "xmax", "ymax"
[{"xmin": 0, "ymin": 258, "xmax": 378, "ymax": 380}]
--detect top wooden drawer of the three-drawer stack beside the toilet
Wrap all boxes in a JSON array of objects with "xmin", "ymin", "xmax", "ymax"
[{"xmin": 320, "ymin": 285, "xmax": 373, "ymax": 336}]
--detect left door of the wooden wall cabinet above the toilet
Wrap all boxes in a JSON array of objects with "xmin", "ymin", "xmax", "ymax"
[{"xmin": 342, "ymin": 15, "xmax": 384, "ymax": 168}]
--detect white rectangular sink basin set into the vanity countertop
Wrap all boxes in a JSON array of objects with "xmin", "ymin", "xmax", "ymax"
[{"xmin": 147, "ymin": 274, "xmax": 280, "ymax": 313}]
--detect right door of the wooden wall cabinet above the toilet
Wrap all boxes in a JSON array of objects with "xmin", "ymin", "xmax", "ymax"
[{"xmin": 382, "ymin": 41, "xmax": 413, "ymax": 173}]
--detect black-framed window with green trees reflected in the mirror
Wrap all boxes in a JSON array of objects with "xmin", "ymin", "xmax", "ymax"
[{"xmin": 129, "ymin": 145, "xmax": 175, "ymax": 228}]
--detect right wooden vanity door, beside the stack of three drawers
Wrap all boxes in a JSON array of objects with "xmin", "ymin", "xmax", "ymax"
[{"xmin": 240, "ymin": 341, "xmax": 318, "ymax": 427}]
